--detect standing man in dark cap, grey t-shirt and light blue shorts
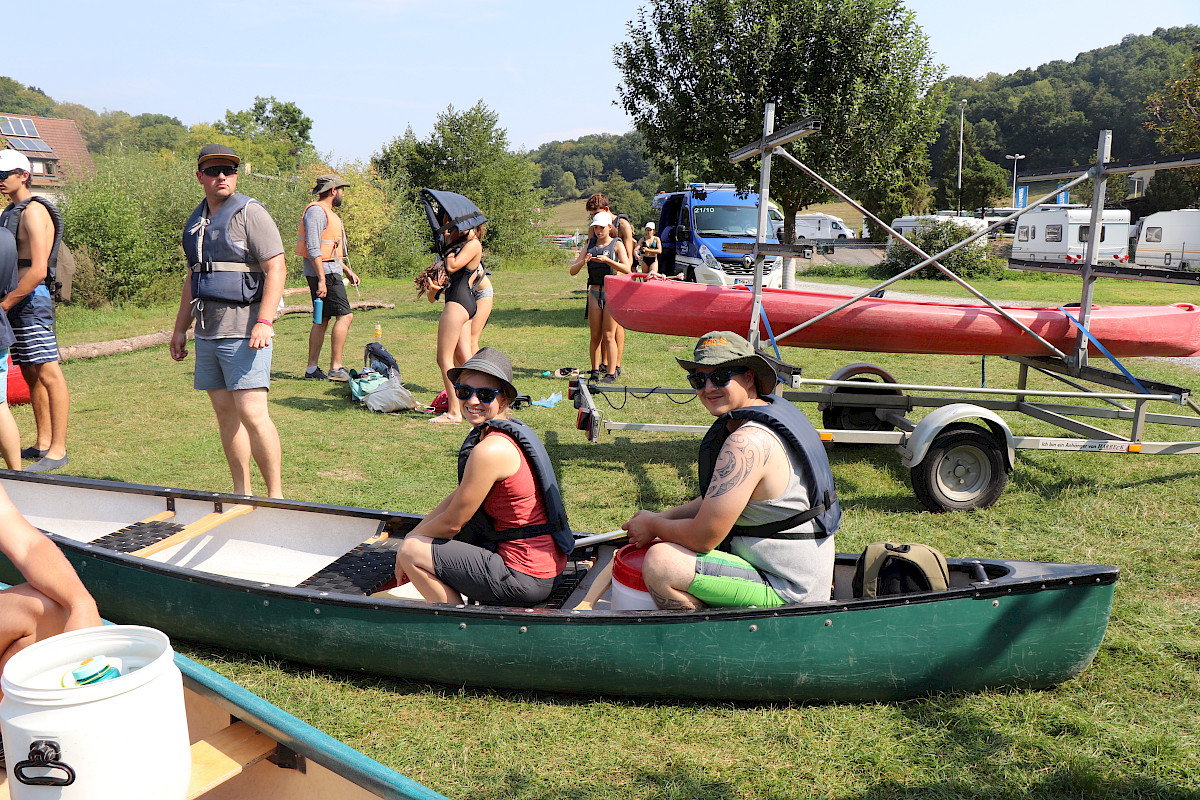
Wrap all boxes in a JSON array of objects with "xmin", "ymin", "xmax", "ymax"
[{"xmin": 170, "ymin": 144, "xmax": 287, "ymax": 498}]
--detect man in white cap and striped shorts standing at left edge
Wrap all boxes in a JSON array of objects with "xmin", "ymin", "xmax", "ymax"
[{"xmin": 0, "ymin": 150, "xmax": 71, "ymax": 473}]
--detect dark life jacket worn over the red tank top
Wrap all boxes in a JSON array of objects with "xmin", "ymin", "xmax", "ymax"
[{"xmin": 458, "ymin": 420, "xmax": 575, "ymax": 555}]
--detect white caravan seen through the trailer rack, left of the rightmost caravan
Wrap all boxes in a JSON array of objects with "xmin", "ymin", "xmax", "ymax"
[{"xmin": 1012, "ymin": 205, "xmax": 1129, "ymax": 264}]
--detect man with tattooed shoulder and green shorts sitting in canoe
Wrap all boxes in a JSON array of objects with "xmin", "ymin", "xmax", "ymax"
[{"xmin": 623, "ymin": 331, "xmax": 841, "ymax": 609}]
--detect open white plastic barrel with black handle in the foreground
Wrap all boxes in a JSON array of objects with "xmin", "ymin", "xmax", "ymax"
[{"xmin": 0, "ymin": 625, "xmax": 192, "ymax": 800}]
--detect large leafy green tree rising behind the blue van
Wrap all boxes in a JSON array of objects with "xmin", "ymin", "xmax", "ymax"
[{"xmin": 614, "ymin": 0, "xmax": 942, "ymax": 242}]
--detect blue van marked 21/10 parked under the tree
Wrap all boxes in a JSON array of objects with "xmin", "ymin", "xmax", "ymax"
[{"xmin": 652, "ymin": 184, "xmax": 784, "ymax": 289}]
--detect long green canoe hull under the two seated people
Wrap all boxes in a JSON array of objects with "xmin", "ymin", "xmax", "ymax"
[{"xmin": 0, "ymin": 472, "xmax": 1117, "ymax": 702}]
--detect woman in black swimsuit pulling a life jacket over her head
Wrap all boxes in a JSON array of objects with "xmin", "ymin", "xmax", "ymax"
[{"xmin": 431, "ymin": 219, "xmax": 491, "ymax": 425}]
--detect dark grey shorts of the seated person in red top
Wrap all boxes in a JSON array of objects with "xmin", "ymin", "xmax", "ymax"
[{"xmin": 433, "ymin": 539, "xmax": 554, "ymax": 606}]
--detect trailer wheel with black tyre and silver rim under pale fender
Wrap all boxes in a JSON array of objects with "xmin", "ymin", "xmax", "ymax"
[{"xmin": 911, "ymin": 422, "xmax": 1008, "ymax": 512}]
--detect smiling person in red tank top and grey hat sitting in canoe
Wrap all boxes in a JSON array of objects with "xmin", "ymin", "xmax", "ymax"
[{"xmin": 396, "ymin": 348, "xmax": 574, "ymax": 606}]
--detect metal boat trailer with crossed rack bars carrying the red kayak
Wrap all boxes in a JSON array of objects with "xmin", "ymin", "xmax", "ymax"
[{"xmin": 569, "ymin": 110, "xmax": 1200, "ymax": 511}]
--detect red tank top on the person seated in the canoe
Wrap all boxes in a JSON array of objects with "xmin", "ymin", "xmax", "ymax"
[{"xmin": 482, "ymin": 429, "xmax": 566, "ymax": 578}]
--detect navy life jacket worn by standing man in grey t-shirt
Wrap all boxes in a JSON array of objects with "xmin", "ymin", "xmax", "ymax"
[{"xmin": 184, "ymin": 194, "xmax": 264, "ymax": 306}]
